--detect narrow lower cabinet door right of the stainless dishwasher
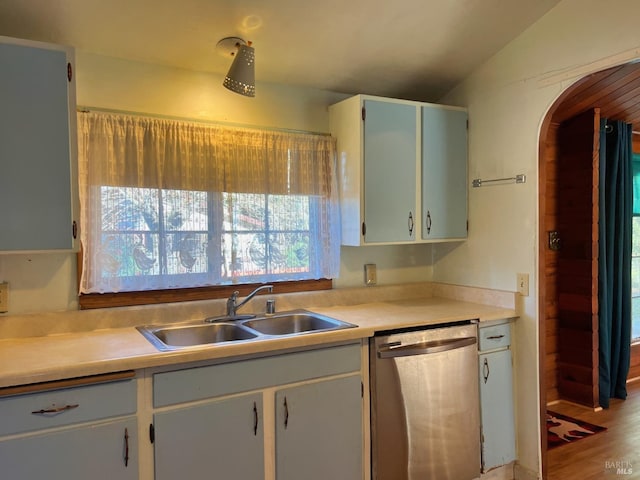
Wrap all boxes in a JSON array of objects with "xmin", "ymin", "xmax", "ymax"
[{"xmin": 479, "ymin": 350, "xmax": 516, "ymax": 472}]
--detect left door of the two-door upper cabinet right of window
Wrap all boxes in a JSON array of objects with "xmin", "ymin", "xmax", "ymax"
[{"xmin": 364, "ymin": 100, "xmax": 418, "ymax": 243}]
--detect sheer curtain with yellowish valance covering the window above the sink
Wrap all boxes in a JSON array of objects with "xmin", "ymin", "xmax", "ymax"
[{"xmin": 78, "ymin": 112, "xmax": 340, "ymax": 293}]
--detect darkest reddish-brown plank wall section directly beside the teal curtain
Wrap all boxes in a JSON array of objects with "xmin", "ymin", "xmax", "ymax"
[{"xmin": 556, "ymin": 109, "xmax": 600, "ymax": 407}]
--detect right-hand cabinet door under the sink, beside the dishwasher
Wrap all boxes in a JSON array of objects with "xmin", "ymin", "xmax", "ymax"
[{"xmin": 276, "ymin": 376, "xmax": 363, "ymax": 480}]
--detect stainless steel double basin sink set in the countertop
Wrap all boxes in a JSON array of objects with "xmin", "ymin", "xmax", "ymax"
[{"xmin": 137, "ymin": 310, "xmax": 356, "ymax": 351}]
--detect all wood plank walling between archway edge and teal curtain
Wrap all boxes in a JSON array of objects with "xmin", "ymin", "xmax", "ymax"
[{"xmin": 543, "ymin": 110, "xmax": 599, "ymax": 406}]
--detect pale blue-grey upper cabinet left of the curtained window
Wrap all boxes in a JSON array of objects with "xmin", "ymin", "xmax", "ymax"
[{"xmin": 0, "ymin": 36, "xmax": 79, "ymax": 253}]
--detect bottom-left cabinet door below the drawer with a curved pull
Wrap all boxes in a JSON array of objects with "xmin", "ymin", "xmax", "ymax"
[{"xmin": 0, "ymin": 419, "xmax": 138, "ymax": 480}]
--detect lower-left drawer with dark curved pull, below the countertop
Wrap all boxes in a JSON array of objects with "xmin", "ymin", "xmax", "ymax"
[{"xmin": 0, "ymin": 379, "xmax": 137, "ymax": 436}]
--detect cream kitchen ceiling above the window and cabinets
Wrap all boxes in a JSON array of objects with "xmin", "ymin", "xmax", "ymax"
[{"xmin": 0, "ymin": 0, "xmax": 560, "ymax": 101}]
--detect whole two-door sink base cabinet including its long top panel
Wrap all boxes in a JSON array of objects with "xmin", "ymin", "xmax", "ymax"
[{"xmin": 152, "ymin": 343, "xmax": 364, "ymax": 480}]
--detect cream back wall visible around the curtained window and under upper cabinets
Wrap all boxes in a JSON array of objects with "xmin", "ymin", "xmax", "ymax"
[{"xmin": 0, "ymin": 52, "xmax": 431, "ymax": 314}]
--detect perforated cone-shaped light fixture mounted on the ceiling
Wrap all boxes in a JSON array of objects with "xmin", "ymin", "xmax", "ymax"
[{"xmin": 216, "ymin": 37, "xmax": 256, "ymax": 97}]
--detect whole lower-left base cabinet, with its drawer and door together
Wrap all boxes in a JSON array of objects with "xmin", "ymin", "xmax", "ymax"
[{"xmin": 0, "ymin": 380, "xmax": 138, "ymax": 480}]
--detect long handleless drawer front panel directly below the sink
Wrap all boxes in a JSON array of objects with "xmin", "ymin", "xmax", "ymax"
[{"xmin": 153, "ymin": 343, "xmax": 361, "ymax": 407}]
